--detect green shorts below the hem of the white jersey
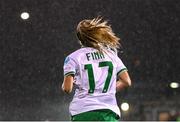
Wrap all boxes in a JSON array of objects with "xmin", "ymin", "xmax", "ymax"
[{"xmin": 71, "ymin": 109, "xmax": 119, "ymax": 121}]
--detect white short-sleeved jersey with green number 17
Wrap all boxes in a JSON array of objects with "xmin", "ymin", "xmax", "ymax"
[{"xmin": 64, "ymin": 47, "xmax": 126, "ymax": 116}]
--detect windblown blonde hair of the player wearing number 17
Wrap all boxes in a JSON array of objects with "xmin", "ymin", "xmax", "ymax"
[{"xmin": 76, "ymin": 17, "xmax": 120, "ymax": 51}]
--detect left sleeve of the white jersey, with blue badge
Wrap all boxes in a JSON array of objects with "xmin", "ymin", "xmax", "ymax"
[{"xmin": 63, "ymin": 56, "xmax": 76, "ymax": 76}]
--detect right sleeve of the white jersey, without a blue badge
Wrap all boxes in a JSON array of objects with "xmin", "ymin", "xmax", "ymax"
[{"xmin": 116, "ymin": 57, "xmax": 127, "ymax": 76}]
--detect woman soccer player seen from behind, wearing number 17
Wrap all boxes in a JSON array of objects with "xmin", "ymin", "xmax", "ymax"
[{"xmin": 62, "ymin": 17, "xmax": 131, "ymax": 121}]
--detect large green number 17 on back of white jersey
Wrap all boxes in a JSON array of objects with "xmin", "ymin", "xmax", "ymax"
[{"xmin": 85, "ymin": 61, "xmax": 113, "ymax": 93}]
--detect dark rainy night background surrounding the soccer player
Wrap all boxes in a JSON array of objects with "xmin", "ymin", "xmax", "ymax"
[{"xmin": 0, "ymin": 0, "xmax": 180, "ymax": 120}]
